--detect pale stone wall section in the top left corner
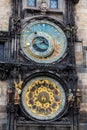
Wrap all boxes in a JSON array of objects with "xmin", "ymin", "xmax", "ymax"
[{"xmin": 0, "ymin": 0, "xmax": 11, "ymax": 31}]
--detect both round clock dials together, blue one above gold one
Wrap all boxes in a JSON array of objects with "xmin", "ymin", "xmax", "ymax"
[{"xmin": 20, "ymin": 17, "xmax": 68, "ymax": 123}]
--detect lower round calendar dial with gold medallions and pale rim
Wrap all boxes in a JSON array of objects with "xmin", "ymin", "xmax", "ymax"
[{"xmin": 22, "ymin": 77, "xmax": 66, "ymax": 120}]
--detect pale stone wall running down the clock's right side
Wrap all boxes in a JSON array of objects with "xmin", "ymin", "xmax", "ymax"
[{"xmin": 75, "ymin": 0, "xmax": 87, "ymax": 119}]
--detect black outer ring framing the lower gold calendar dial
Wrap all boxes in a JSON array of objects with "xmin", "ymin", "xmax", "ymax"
[{"xmin": 20, "ymin": 70, "xmax": 69, "ymax": 123}]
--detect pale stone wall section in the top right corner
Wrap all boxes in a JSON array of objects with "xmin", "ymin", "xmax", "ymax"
[{"xmin": 75, "ymin": 0, "xmax": 87, "ymax": 41}]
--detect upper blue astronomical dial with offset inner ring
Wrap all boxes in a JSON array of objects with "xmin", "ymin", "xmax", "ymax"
[{"xmin": 21, "ymin": 20, "xmax": 67, "ymax": 63}]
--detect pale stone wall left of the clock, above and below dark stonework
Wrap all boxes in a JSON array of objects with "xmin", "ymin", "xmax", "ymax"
[{"xmin": 0, "ymin": 0, "xmax": 12, "ymax": 130}]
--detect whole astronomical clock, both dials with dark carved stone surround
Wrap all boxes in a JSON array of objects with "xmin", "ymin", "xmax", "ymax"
[{"xmin": 5, "ymin": 0, "xmax": 78, "ymax": 130}]
